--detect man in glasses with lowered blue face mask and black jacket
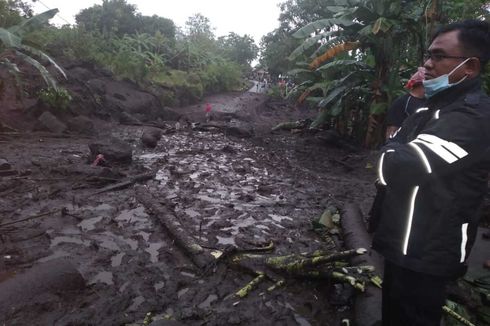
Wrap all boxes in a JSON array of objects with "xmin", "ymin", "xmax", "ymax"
[{"xmin": 373, "ymin": 20, "xmax": 490, "ymax": 326}]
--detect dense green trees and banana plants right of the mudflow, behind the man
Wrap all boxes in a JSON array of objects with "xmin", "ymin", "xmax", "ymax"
[{"xmin": 261, "ymin": 0, "xmax": 490, "ymax": 146}]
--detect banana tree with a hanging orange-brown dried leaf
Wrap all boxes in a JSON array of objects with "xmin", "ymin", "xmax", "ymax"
[{"xmin": 290, "ymin": 0, "xmax": 423, "ymax": 147}]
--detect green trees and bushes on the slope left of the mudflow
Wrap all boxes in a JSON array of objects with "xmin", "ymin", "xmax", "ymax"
[{"xmin": 0, "ymin": 0, "xmax": 258, "ymax": 105}]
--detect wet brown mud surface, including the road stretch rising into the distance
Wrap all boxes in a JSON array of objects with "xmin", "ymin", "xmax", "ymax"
[{"xmin": 0, "ymin": 93, "xmax": 375, "ymax": 325}]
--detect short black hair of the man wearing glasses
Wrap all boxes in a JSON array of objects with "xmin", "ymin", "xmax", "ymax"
[{"xmin": 432, "ymin": 19, "xmax": 490, "ymax": 70}]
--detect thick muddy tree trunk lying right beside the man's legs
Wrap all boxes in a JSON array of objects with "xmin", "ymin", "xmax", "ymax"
[{"xmin": 340, "ymin": 203, "xmax": 383, "ymax": 326}]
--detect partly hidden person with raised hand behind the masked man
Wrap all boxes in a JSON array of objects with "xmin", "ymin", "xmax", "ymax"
[{"xmin": 385, "ymin": 67, "xmax": 425, "ymax": 140}]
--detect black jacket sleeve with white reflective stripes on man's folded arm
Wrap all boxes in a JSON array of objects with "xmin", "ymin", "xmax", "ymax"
[{"xmin": 378, "ymin": 107, "xmax": 490, "ymax": 185}]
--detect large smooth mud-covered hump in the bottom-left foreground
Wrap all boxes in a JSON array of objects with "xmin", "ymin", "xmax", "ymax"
[{"xmin": 0, "ymin": 259, "xmax": 85, "ymax": 321}]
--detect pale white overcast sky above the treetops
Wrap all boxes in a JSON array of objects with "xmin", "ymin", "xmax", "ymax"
[{"xmin": 32, "ymin": 0, "xmax": 285, "ymax": 45}]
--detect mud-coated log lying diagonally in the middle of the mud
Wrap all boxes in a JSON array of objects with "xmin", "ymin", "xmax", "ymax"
[{"xmin": 136, "ymin": 187, "xmax": 215, "ymax": 268}]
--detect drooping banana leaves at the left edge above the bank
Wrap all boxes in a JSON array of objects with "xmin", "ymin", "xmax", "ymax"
[{"xmin": 0, "ymin": 9, "xmax": 66, "ymax": 90}]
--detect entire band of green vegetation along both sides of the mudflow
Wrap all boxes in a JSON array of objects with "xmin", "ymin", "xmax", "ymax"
[{"xmin": 0, "ymin": 0, "xmax": 490, "ymax": 146}]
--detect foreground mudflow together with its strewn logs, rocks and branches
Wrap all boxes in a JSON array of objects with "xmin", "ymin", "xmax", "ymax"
[{"xmin": 0, "ymin": 111, "xmax": 378, "ymax": 325}]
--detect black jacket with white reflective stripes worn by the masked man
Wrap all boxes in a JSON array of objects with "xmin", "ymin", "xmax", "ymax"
[{"xmin": 373, "ymin": 78, "xmax": 490, "ymax": 277}]
